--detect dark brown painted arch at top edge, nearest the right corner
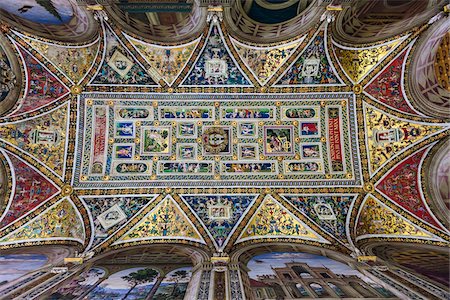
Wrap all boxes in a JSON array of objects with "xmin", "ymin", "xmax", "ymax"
[{"xmin": 332, "ymin": 0, "xmax": 445, "ymax": 43}]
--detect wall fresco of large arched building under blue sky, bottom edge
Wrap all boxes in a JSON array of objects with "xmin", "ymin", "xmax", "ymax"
[{"xmin": 247, "ymin": 252, "xmax": 394, "ymax": 300}]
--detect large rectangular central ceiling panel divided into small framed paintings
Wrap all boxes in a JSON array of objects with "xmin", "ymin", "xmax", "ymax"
[{"xmin": 75, "ymin": 93, "xmax": 360, "ymax": 187}]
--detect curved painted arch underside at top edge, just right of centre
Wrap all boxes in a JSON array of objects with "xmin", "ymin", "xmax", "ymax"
[{"xmin": 224, "ymin": 0, "xmax": 325, "ymax": 43}]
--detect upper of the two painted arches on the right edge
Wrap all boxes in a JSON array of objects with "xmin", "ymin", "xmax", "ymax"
[{"xmin": 405, "ymin": 17, "xmax": 450, "ymax": 119}]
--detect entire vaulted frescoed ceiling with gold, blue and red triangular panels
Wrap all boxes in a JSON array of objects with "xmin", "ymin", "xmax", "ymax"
[{"xmin": 0, "ymin": 1, "xmax": 450, "ymax": 270}]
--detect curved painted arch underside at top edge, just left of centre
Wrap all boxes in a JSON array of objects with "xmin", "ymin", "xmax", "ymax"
[{"xmin": 105, "ymin": 0, "xmax": 207, "ymax": 44}]
